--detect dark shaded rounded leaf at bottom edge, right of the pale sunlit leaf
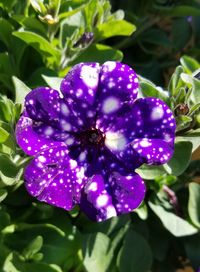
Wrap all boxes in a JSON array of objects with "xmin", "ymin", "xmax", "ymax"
[{"xmin": 117, "ymin": 229, "xmax": 153, "ymax": 272}]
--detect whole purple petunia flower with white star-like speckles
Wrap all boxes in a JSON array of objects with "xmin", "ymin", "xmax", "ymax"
[{"xmin": 16, "ymin": 61, "xmax": 175, "ymax": 221}]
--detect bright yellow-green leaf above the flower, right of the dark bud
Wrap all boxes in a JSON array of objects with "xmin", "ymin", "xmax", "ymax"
[{"xmin": 94, "ymin": 20, "xmax": 136, "ymax": 41}]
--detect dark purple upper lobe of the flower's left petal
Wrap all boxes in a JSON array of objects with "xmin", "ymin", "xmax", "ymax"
[{"xmin": 25, "ymin": 87, "xmax": 83, "ymax": 132}]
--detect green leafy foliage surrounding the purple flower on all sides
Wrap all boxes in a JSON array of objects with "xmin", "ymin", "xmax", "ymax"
[{"xmin": 0, "ymin": 0, "xmax": 200, "ymax": 272}]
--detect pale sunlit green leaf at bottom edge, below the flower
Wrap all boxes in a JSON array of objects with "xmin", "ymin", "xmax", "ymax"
[{"xmin": 83, "ymin": 232, "xmax": 113, "ymax": 272}]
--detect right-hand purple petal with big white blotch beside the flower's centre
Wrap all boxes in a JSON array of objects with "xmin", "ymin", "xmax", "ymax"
[{"xmin": 105, "ymin": 98, "xmax": 176, "ymax": 164}]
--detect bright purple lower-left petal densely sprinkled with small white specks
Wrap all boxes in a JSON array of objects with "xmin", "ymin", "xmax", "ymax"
[{"xmin": 24, "ymin": 147, "xmax": 85, "ymax": 210}]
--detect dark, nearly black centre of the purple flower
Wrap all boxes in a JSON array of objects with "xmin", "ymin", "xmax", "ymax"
[{"xmin": 78, "ymin": 128, "xmax": 105, "ymax": 146}]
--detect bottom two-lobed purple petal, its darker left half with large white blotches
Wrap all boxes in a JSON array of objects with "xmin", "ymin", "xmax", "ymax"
[{"xmin": 80, "ymin": 172, "xmax": 145, "ymax": 221}]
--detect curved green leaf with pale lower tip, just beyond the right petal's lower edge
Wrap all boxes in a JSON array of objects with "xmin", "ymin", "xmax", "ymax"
[{"xmin": 163, "ymin": 141, "xmax": 192, "ymax": 176}]
